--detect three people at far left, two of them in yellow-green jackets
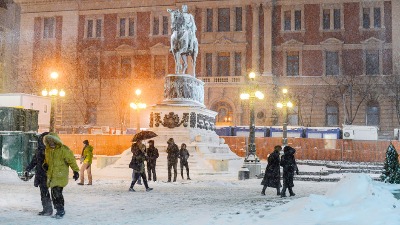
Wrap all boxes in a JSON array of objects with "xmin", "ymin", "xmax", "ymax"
[{"xmin": 24, "ymin": 132, "xmax": 93, "ymax": 219}]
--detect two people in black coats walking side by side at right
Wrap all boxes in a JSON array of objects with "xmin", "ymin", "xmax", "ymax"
[{"xmin": 261, "ymin": 145, "xmax": 299, "ymax": 197}]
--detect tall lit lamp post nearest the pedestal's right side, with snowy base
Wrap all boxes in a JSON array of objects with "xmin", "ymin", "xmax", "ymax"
[{"xmin": 239, "ymin": 72, "xmax": 264, "ymax": 177}]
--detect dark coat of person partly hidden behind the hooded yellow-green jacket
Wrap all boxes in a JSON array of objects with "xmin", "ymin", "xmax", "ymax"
[{"xmin": 25, "ymin": 132, "xmax": 49, "ymax": 187}]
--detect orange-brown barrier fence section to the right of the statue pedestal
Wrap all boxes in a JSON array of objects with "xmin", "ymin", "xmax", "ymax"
[{"xmin": 223, "ymin": 137, "xmax": 400, "ymax": 162}]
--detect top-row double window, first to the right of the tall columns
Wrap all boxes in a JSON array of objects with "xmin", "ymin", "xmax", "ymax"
[{"xmin": 282, "ymin": 7, "xmax": 304, "ymax": 31}]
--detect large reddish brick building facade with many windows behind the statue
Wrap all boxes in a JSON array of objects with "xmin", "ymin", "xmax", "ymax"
[{"xmin": 10, "ymin": 0, "xmax": 400, "ymax": 137}]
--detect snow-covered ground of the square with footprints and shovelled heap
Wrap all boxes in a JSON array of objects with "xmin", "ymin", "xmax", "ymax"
[{"xmin": 0, "ymin": 150, "xmax": 400, "ymax": 225}]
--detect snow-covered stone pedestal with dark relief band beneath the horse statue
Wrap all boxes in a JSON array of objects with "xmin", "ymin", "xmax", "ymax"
[{"xmin": 150, "ymin": 75, "xmax": 240, "ymax": 171}]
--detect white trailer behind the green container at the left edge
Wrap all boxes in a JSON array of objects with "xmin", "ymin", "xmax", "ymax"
[{"xmin": 0, "ymin": 93, "xmax": 51, "ymax": 133}]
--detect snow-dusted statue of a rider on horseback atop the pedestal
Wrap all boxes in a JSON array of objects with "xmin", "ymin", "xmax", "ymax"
[{"xmin": 167, "ymin": 5, "xmax": 199, "ymax": 77}]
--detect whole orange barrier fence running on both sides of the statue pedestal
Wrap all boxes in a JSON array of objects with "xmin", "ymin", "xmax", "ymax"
[{"xmin": 59, "ymin": 134, "xmax": 400, "ymax": 162}]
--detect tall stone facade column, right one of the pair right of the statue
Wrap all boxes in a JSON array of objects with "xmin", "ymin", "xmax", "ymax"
[{"xmin": 263, "ymin": 3, "xmax": 272, "ymax": 76}]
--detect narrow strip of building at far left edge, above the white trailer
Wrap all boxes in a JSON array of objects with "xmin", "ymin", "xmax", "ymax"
[{"xmin": 0, "ymin": 0, "xmax": 20, "ymax": 93}]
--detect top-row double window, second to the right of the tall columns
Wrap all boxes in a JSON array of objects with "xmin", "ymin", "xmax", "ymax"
[{"xmin": 321, "ymin": 5, "xmax": 342, "ymax": 30}]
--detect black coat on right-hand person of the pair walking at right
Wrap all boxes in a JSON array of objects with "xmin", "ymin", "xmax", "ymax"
[{"xmin": 281, "ymin": 146, "xmax": 299, "ymax": 187}]
